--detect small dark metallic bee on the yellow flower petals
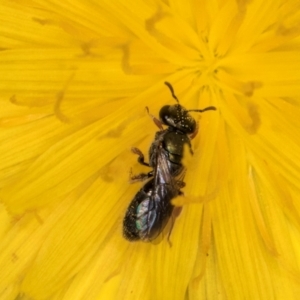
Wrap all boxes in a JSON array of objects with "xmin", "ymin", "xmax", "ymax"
[{"xmin": 123, "ymin": 82, "xmax": 216, "ymax": 242}]
